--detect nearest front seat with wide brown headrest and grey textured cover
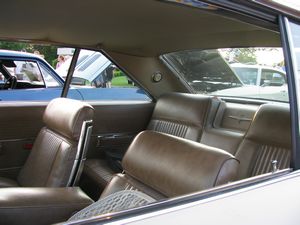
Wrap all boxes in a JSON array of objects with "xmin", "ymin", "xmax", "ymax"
[{"xmin": 71, "ymin": 131, "xmax": 239, "ymax": 220}]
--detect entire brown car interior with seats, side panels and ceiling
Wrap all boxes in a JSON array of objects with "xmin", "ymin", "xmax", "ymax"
[{"xmin": 0, "ymin": 0, "xmax": 293, "ymax": 224}]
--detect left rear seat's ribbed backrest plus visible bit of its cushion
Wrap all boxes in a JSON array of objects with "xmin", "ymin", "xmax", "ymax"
[{"xmin": 84, "ymin": 93, "xmax": 214, "ymax": 192}]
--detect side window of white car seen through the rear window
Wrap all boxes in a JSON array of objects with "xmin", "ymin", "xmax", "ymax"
[{"xmin": 260, "ymin": 69, "xmax": 286, "ymax": 86}]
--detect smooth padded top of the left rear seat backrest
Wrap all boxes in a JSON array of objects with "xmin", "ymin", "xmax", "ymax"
[{"xmin": 152, "ymin": 93, "xmax": 212, "ymax": 127}]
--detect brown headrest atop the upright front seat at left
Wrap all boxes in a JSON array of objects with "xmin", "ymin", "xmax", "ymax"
[{"xmin": 43, "ymin": 98, "xmax": 94, "ymax": 141}]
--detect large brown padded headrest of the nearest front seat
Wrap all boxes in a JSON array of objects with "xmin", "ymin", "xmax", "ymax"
[{"xmin": 122, "ymin": 131, "xmax": 239, "ymax": 197}]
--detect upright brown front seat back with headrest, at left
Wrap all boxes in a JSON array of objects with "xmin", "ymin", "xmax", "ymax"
[{"xmin": 18, "ymin": 98, "xmax": 94, "ymax": 187}]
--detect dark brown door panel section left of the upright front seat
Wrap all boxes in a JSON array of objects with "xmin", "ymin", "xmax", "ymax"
[{"xmin": 0, "ymin": 102, "xmax": 47, "ymax": 178}]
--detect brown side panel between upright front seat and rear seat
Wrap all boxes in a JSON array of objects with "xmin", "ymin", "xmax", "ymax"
[{"xmin": 87, "ymin": 101, "xmax": 154, "ymax": 161}]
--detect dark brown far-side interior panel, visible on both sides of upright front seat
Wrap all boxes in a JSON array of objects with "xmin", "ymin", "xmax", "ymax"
[{"xmin": 0, "ymin": 101, "xmax": 154, "ymax": 178}]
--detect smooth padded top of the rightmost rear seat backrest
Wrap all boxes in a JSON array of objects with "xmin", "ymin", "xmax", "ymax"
[{"xmin": 245, "ymin": 104, "xmax": 291, "ymax": 148}]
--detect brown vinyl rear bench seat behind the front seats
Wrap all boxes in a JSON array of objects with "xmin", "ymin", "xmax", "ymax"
[{"xmin": 84, "ymin": 93, "xmax": 291, "ymax": 198}]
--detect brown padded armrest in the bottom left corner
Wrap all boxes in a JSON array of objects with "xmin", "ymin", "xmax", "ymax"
[{"xmin": 0, "ymin": 187, "xmax": 93, "ymax": 225}]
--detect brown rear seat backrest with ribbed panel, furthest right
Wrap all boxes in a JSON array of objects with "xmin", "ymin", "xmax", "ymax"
[{"xmin": 235, "ymin": 104, "xmax": 291, "ymax": 179}]
